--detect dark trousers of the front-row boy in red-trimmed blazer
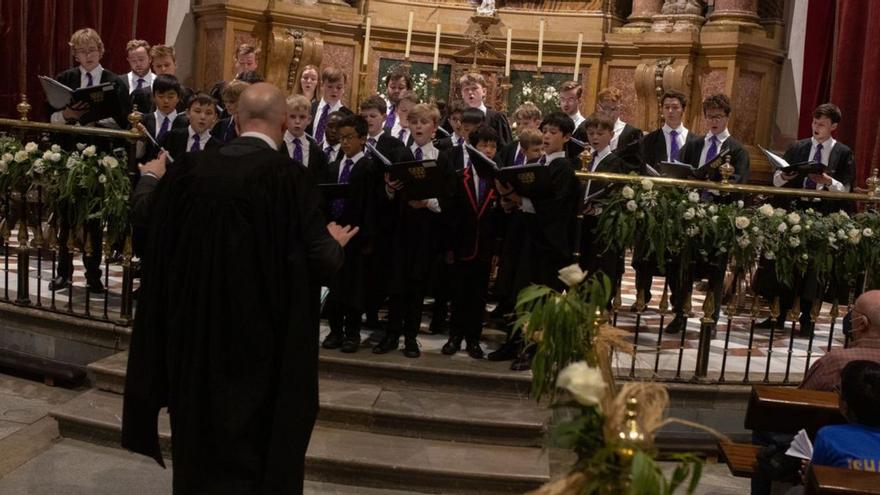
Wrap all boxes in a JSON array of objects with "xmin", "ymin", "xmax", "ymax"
[{"xmin": 449, "ymin": 260, "xmax": 491, "ymax": 344}]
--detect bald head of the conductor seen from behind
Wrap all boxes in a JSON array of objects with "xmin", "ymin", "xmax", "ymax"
[{"xmin": 237, "ymin": 83, "xmax": 287, "ymax": 144}]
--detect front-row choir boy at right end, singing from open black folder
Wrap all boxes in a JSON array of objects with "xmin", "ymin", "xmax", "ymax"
[{"xmin": 489, "ymin": 112, "xmax": 582, "ymax": 370}]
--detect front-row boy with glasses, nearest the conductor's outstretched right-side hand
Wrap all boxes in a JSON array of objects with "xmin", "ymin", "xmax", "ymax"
[{"xmin": 319, "ymin": 116, "xmax": 384, "ymax": 353}]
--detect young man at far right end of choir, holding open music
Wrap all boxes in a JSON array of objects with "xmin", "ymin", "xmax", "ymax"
[{"xmin": 758, "ymin": 103, "xmax": 855, "ymax": 335}]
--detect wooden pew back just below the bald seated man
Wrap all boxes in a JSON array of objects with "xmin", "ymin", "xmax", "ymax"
[{"xmin": 745, "ymin": 385, "xmax": 846, "ymax": 437}]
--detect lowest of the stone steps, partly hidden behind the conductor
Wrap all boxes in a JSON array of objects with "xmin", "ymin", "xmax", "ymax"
[{"xmin": 50, "ymin": 390, "xmax": 550, "ymax": 493}]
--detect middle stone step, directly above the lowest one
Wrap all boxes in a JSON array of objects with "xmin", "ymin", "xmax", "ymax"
[{"xmin": 89, "ymin": 353, "xmax": 550, "ymax": 447}]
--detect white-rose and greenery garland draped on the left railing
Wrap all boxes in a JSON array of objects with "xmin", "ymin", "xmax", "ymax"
[{"xmin": 0, "ymin": 136, "xmax": 131, "ymax": 246}]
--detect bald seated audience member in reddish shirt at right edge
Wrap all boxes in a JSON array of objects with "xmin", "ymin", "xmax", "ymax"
[{"xmin": 800, "ymin": 290, "xmax": 880, "ymax": 392}]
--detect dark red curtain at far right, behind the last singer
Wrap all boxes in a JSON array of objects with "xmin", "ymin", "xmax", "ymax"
[{"xmin": 799, "ymin": 0, "xmax": 880, "ymax": 186}]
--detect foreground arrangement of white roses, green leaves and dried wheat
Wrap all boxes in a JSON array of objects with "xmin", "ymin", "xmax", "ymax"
[{"xmin": 516, "ymin": 265, "xmax": 702, "ymax": 495}]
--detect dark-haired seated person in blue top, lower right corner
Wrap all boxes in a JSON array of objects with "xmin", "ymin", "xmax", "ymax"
[{"xmin": 810, "ymin": 361, "xmax": 880, "ymax": 473}]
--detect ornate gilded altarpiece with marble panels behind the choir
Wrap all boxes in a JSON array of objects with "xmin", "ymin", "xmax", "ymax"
[{"xmin": 192, "ymin": 0, "xmax": 785, "ymax": 181}]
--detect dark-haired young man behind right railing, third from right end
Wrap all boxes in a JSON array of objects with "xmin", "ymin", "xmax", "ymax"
[{"xmin": 630, "ymin": 90, "xmax": 700, "ymax": 310}]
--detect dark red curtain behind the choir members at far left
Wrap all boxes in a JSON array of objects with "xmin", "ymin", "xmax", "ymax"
[{"xmin": 0, "ymin": 0, "xmax": 168, "ymax": 120}]
